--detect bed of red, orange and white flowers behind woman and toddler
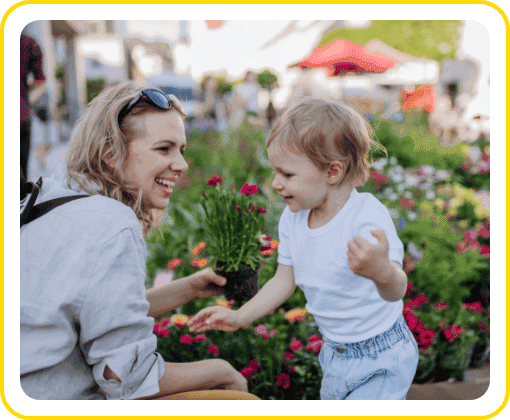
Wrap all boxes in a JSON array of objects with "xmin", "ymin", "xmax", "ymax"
[{"xmin": 147, "ymin": 117, "xmax": 490, "ymax": 399}]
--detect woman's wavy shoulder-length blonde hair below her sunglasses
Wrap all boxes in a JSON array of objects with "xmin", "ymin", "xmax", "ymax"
[{"xmin": 66, "ymin": 82, "xmax": 183, "ymax": 234}]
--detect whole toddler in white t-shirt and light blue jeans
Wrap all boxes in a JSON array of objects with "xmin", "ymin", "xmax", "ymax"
[{"xmin": 189, "ymin": 98, "xmax": 418, "ymax": 400}]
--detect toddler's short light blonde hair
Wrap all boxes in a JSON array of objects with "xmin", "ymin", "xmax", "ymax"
[{"xmin": 267, "ymin": 97, "xmax": 385, "ymax": 186}]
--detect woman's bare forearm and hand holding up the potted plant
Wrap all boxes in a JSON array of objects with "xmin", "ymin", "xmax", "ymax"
[{"xmin": 146, "ymin": 268, "xmax": 226, "ymax": 318}]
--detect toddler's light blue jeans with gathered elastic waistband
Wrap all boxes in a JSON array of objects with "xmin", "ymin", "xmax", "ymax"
[{"xmin": 319, "ymin": 316, "xmax": 418, "ymax": 400}]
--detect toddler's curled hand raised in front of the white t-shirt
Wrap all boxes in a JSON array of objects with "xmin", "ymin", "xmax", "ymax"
[{"xmin": 347, "ymin": 229, "xmax": 391, "ymax": 284}]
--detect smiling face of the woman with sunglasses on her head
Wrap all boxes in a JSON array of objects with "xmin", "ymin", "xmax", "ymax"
[{"xmin": 125, "ymin": 110, "xmax": 188, "ymax": 209}]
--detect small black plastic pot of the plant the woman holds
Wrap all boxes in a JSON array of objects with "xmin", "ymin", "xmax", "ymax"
[{"xmin": 215, "ymin": 263, "xmax": 259, "ymax": 302}]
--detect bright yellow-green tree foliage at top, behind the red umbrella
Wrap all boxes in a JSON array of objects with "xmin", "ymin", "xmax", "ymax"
[{"xmin": 318, "ymin": 20, "xmax": 462, "ymax": 61}]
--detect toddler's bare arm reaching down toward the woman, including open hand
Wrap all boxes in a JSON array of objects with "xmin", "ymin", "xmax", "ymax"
[{"xmin": 188, "ymin": 264, "xmax": 296, "ymax": 332}]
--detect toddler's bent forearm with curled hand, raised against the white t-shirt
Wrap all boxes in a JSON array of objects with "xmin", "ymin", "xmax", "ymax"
[{"xmin": 347, "ymin": 229, "xmax": 407, "ymax": 302}]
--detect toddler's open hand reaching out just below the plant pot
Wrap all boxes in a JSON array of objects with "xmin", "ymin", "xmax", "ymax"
[{"xmin": 188, "ymin": 306, "xmax": 242, "ymax": 332}]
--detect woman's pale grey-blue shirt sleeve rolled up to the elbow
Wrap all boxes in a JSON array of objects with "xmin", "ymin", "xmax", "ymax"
[{"xmin": 79, "ymin": 229, "xmax": 165, "ymax": 399}]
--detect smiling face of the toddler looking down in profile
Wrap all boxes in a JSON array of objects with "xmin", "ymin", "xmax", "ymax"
[{"xmin": 267, "ymin": 143, "xmax": 328, "ymax": 212}]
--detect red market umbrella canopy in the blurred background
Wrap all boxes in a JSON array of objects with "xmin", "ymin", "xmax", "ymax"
[{"xmin": 293, "ymin": 39, "xmax": 398, "ymax": 76}]
